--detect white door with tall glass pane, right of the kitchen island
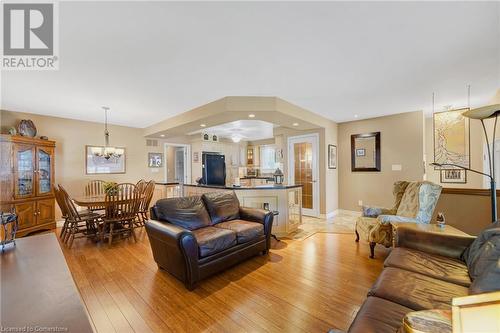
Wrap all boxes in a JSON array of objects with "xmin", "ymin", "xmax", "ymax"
[{"xmin": 288, "ymin": 134, "xmax": 319, "ymax": 217}]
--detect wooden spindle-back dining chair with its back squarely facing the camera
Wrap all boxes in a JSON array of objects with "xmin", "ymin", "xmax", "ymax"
[{"xmin": 100, "ymin": 183, "xmax": 141, "ymax": 245}]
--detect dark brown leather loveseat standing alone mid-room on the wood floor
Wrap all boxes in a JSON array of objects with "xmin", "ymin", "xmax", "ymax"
[{"xmin": 146, "ymin": 192, "xmax": 273, "ymax": 290}]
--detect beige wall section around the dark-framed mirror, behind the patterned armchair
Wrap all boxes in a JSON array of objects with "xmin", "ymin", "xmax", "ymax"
[{"xmin": 338, "ymin": 111, "xmax": 424, "ymax": 211}]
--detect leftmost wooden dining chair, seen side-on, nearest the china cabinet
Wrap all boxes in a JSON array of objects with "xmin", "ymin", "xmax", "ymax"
[{"xmin": 59, "ymin": 185, "xmax": 100, "ymax": 248}]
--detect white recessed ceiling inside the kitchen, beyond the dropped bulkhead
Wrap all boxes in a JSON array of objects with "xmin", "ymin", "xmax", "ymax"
[{"xmin": 188, "ymin": 120, "xmax": 275, "ymax": 141}]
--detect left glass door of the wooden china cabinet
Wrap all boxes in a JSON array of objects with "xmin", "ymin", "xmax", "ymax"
[{"xmin": 14, "ymin": 145, "xmax": 35, "ymax": 198}]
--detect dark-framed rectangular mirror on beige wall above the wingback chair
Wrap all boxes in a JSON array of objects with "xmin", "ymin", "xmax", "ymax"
[{"xmin": 351, "ymin": 132, "xmax": 381, "ymax": 171}]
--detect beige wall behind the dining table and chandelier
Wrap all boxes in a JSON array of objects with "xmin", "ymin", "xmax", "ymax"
[{"xmin": 0, "ymin": 111, "xmax": 164, "ymax": 216}]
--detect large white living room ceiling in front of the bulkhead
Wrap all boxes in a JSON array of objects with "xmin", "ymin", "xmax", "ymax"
[{"xmin": 1, "ymin": 2, "xmax": 500, "ymax": 127}]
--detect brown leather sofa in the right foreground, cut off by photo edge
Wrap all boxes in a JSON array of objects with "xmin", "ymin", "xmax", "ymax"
[{"xmin": 344, "ymin": 222, "xmax": 500, "ymax": 333}]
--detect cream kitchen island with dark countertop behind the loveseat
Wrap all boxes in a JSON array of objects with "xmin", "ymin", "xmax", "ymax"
[{"xmin": 183, "ymin": 184, "xmax": 302, "ymax": 237}]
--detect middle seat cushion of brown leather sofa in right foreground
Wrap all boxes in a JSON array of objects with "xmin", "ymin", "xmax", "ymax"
[{"xmin": 368, "ymin": 267, "xmax": 468, "ymax": 310}]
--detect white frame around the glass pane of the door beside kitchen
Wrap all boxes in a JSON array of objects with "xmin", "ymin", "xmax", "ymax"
[{"xmin": 287, "ymin": 133, "xmax": 320, "ymax": 217}]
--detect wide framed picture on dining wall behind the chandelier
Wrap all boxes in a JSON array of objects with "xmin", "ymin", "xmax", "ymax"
[{"xmin": 85, "ymin": 146, "xmax": 126, "ymax": 175}]
